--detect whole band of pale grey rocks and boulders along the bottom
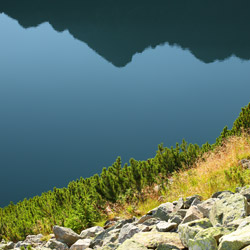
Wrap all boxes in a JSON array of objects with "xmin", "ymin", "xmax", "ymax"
[{"xmin": 0, "ymin": 187, "xmax": 250, "ymax": 250}]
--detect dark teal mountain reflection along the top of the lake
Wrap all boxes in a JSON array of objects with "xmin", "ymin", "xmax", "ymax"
[{"xmin": 0, "ymin": 0, "xmax": 250, "ymax": 67}]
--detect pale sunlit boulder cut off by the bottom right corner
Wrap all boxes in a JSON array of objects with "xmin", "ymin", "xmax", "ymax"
[{"xmin": 218, "ymin": 225, "xmax": 250, "ymax": 250}]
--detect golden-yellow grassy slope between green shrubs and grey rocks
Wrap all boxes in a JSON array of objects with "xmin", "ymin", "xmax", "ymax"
[{"xmin": 111, "ymin": 134, "xmax": 250, "ymax": 217}]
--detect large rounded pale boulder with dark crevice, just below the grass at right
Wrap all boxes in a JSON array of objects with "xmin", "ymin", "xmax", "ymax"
[{"xmin": 209, "ymin": 193, "xmax": 247, "ymax": 226}]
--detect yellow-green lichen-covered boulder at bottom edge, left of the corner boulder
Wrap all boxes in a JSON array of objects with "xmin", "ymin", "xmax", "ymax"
[{"xmin": 188, "ymin": 227, "xmax": 233, "ymax": 250}]
